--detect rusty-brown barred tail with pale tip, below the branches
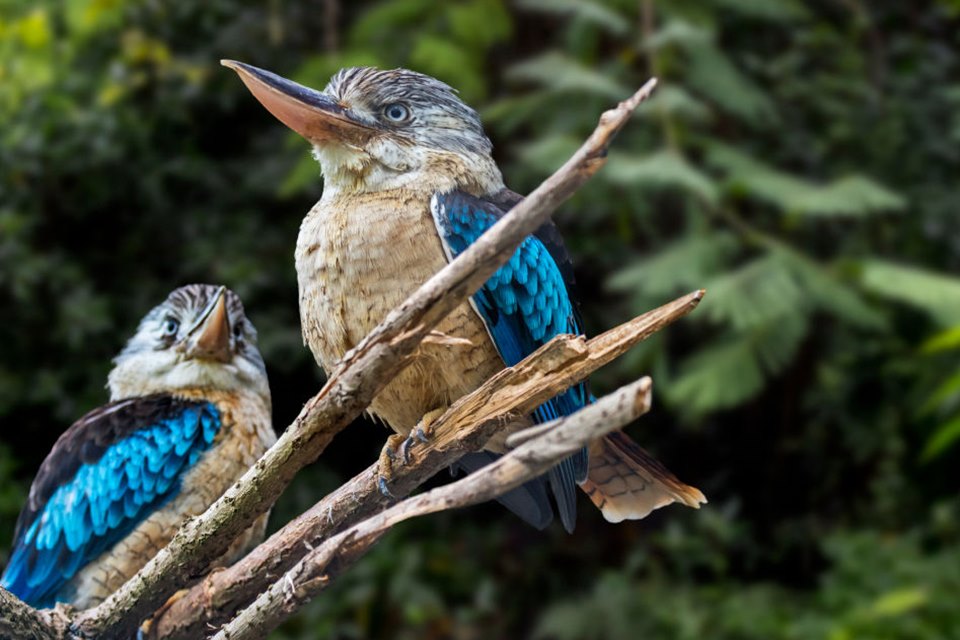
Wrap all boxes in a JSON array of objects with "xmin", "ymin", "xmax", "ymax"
[{"xmin": 581, "ymin": 432, "xmax": 707, "ymax": 522}]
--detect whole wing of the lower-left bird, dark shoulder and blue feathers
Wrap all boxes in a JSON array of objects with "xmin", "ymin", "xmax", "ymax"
[{"xmin": 0, "ymin": 396, "xmax": 220, "ymax": 607}]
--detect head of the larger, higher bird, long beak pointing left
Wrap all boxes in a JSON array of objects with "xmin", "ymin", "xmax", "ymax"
[{"xmin": 223, "ymin": 60, "xmax": 503, "ymax": 195}]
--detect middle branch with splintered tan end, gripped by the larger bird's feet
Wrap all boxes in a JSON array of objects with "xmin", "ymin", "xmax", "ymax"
[{"xmin": 148, "ymin": 290, "xmax": 703, "ymax": 640}]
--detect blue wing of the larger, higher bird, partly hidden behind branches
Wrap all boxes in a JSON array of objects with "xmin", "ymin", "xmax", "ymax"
[{"xmin": 432, "ymin": 192, "xmax": 589, "ymax": 530}]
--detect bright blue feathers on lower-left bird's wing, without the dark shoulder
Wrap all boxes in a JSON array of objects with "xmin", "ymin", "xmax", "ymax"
[{"xmin": 0, "ymin": 402, "xmax": 220, "ymax": 607}]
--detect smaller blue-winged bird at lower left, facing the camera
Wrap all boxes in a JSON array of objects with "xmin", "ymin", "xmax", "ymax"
[{"xmin": 0, "ymin": 284, "xmax": 276, "ymax": 609}]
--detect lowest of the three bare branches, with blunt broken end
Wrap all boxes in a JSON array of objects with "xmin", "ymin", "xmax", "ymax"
[{"xmin": 214, "ymin": 378, "xmax": 651, "ymax": 640}]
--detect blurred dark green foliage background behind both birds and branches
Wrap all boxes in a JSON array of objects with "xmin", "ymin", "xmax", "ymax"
[{"xmin": 0, "ymin": 0, "xmax": 960, "ymax": 640}]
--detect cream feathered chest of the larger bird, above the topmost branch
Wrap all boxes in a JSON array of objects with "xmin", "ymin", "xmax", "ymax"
[{"xmin": 296, "ymin": 190, "xmax": 447, "ymax": 371}]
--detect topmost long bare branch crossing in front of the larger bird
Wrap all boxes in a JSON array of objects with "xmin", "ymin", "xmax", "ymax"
[{"xmin": 63, "ymin": 80, "xmax": 656, "ymax": 638}]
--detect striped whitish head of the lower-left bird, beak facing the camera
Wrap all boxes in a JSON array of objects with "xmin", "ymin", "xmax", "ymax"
[{"xmin": 107, "ymin": 284, "xmax": 270, "ymax": 406}]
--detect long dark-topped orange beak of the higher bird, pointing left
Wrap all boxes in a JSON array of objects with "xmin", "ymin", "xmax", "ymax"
[{"xmin": 220, "ymin": 60, "xmax": 376, "ymax": 146}]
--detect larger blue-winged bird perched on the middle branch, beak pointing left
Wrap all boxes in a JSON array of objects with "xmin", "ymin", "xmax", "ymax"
[{"xmin": 222, "ymin": 60, "xmax": 705, "ymax": 532}]
